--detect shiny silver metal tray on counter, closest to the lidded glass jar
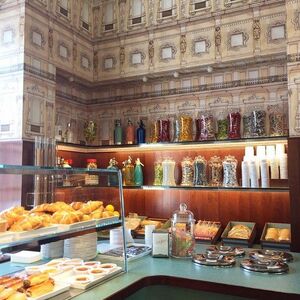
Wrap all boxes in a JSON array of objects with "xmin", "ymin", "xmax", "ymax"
[{"xmin": 193, "ymin": 253, "xmax": 235, "ymax": 267}]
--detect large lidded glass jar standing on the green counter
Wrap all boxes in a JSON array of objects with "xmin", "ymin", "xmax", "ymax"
[{"xmin": 171, "ymin": 203, "xmax": 195, "ymax": 258}]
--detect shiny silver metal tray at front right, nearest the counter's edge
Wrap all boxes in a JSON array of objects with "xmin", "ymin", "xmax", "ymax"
[{"xmin": 240, "ymin": 258, "xmax": 289, "ymax": 274}]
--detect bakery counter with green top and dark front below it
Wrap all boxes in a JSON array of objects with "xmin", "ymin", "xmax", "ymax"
[{"xmin": 75, "ymin": 245, "xmax": 300, "ymax": 300}]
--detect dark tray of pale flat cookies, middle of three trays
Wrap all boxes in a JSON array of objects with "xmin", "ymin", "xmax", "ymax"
[{"xmin": 221, "ymin": 221, "xmax": 256, "ymax": 248}]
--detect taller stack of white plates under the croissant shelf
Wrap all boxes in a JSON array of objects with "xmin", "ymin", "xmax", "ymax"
[{"xmin": 64, "ymin": 232, "xmax": 97, "ymax": 260}]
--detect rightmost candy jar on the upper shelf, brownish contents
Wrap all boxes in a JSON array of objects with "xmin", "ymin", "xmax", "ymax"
[{"xmin": 268, "ymin": 105, "xmax": 285, "ymax": 136}]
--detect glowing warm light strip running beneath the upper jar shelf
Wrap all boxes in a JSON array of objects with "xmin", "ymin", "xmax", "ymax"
[{"xmin": 57, "ymin": 139, "xmax": 287, "ymax": 153}]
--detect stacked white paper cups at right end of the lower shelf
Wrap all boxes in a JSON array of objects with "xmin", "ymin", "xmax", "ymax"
[{"xmin": 242, "ymin": 144, "xmax": 288, "ymax": 188}]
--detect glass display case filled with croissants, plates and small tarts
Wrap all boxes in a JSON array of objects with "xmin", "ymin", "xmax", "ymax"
[{"xmin": 0, "ymin": 165, "xmax": 127, "ymax": 299}]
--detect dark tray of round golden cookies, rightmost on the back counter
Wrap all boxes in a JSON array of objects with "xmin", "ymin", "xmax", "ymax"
[{"xmin": 260, "ymin": 223, "xmax": 291, "ymax": 250}]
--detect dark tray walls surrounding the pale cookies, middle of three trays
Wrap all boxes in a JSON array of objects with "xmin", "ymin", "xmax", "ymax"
[{"xmin": 221, "ymin": 221, "xmax": 256, "ymax": 248}]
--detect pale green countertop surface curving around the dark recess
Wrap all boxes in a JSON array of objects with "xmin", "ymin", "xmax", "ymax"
[{"xmin": 75, "ymin": 245, "xmax": 300, "ymax": 300}]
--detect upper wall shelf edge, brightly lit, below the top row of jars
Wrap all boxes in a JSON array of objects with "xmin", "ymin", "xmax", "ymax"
[{"xmin": 57, "ymin": 136, "xmax": 288, "ymax": 153}]
